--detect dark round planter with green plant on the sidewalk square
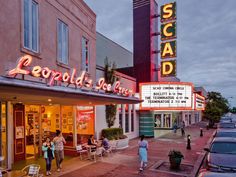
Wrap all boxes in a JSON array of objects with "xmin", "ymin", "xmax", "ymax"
[{"xmin": 168, "ymin": 150, "xmax": 184, "ymax": 169}]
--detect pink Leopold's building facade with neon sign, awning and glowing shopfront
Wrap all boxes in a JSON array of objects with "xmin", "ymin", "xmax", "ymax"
[{"xmin": 0, "ymin": 0, "xmax": 138, "ymax": 169}]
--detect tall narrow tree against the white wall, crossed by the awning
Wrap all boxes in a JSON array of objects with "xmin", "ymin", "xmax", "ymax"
[{"xmin": 104, "ymin": 57, "xmax": 117, "ymax": 128}]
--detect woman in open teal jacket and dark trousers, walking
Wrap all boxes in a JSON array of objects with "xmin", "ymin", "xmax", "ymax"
[{"xmin": 42, "ymin": 138, "xmax": 54, "ymax": 176}]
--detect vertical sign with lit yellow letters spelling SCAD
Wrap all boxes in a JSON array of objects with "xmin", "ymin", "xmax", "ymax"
[{"xmin": 160, "ymin": 2, "xmax": 177, "ymax": 77}]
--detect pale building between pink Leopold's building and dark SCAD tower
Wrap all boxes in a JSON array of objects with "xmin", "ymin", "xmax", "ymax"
[{"xmin": 95, "ymin": 32, "xmax": 139, "ymax": 138}]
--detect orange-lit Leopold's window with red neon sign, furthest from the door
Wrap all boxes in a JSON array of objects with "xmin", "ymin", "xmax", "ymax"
[{"xmin": 76, "ymin": 106, "xmax": 94, "ymax": 144}]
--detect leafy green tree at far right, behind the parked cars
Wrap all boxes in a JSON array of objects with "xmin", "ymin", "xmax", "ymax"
[{"xmin": 203, "ymin": 92, "xmax": 229, "ymax": 127}]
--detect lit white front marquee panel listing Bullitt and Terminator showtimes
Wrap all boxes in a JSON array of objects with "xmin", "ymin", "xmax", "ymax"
[{"xmin": 140, "ymin": 82, "xmax": 193, "ymax": 110}]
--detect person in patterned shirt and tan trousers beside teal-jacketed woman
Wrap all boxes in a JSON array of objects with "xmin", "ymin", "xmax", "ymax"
[{"xmin": 53, "ymin": 130, "xmax": 66, "ymax": 172}]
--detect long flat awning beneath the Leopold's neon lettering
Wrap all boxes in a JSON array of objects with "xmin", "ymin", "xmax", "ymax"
[{"xmin": 0, "ymin": 76, "xmax": 142, "ymax": 105}]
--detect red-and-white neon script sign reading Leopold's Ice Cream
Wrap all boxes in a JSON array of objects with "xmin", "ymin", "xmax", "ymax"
[{"xmin": 8, "ymin": 55, "xmax": 133, "ymax": 96}]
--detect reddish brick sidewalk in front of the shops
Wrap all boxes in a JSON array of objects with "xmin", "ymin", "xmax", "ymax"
[{"xmin": 48, "ymin": 121, "xmax": 214, "ymax": 177}]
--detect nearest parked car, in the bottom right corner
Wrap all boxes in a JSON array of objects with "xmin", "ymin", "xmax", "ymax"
[{"xmin": 204, "ymin": 137, "xmax": 236, "ymax": 173}]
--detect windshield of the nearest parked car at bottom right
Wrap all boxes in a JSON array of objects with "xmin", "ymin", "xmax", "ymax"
[{"xmin": 210, "ymin": 142, "xmax": 236, "ymax": 155}]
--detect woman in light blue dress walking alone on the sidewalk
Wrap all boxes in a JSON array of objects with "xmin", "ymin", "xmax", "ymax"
[{"xmin": 138, "ymin": 135, "xmax": 148, "ymax": 171}]
